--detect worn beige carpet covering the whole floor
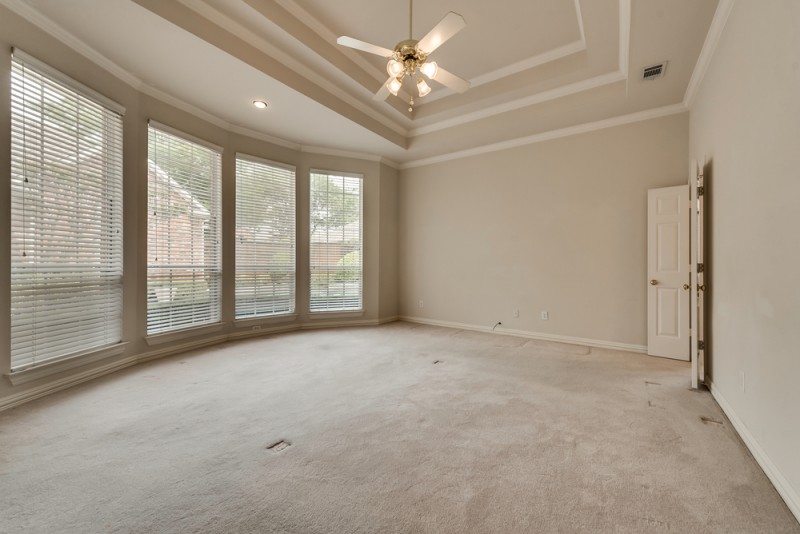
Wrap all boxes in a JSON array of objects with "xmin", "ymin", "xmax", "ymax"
[{"xmin": 0, "ymin": 323, "xmax": 800, "ymax": 534}]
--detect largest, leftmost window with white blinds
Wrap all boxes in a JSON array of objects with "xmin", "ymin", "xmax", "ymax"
[{"xmin": 11, "ymin": 50, "xmax": 124, "ymax": 371}]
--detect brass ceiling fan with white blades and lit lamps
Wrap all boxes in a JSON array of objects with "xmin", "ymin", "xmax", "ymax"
[{"xmin": 336, "ymin": 0, "xmax": 469, "ymax": 111}]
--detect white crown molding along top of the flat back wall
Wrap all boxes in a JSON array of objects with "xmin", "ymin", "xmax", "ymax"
[{"xmin": 400, "ymin": 104, "xmax": 688, "ymax": 169}]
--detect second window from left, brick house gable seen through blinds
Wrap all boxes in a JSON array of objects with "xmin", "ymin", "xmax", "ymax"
[{"xmin": 147, "ymin": 121, "xmax": 221, "ymax": 334}]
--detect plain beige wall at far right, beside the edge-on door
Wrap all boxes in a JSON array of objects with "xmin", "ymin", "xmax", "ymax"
[{"xmin": 690, "ymin": 1, "xmax": 800, "ymax": 517}]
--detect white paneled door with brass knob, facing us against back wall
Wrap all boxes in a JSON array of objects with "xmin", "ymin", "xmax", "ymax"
[{"xmin": 647, "ymin": 185, "xmax": 690, "ymax": 361}]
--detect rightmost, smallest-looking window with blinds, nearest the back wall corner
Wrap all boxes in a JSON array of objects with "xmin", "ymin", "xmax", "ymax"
[{"xmin": 310, "ymin": 171, "xmax": 363, "ymax": 312}]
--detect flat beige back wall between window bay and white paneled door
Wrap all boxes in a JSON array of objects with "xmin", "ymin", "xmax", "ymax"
[{"xmin": 400, "ymin": 113, "xmax": 688, "ymax": 348}]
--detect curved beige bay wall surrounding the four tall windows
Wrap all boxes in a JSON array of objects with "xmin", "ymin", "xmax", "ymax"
[{"xmin": 0, "ymin": 6, "xmax": 397, "ymax": 408}]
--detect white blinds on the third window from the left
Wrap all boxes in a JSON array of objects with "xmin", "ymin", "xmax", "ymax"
[{"xmin": 236, "ymin": 154, "xmax": 295, "ymax": 319}]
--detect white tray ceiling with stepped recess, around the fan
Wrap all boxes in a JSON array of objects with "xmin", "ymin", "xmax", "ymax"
[{"xmin": 0, "ymin": 0, "xmax": 717, "ymax": 165}]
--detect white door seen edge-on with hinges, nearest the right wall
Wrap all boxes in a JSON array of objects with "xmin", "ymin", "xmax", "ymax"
[{"xmin": 689, "ymin": 160, "xmax": 706, "ymax": 388}]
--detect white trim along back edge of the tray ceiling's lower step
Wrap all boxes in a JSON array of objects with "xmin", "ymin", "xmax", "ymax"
[{"xmin": 408, "ymin": 71, "xmax": 625, "ymax": 137}]
